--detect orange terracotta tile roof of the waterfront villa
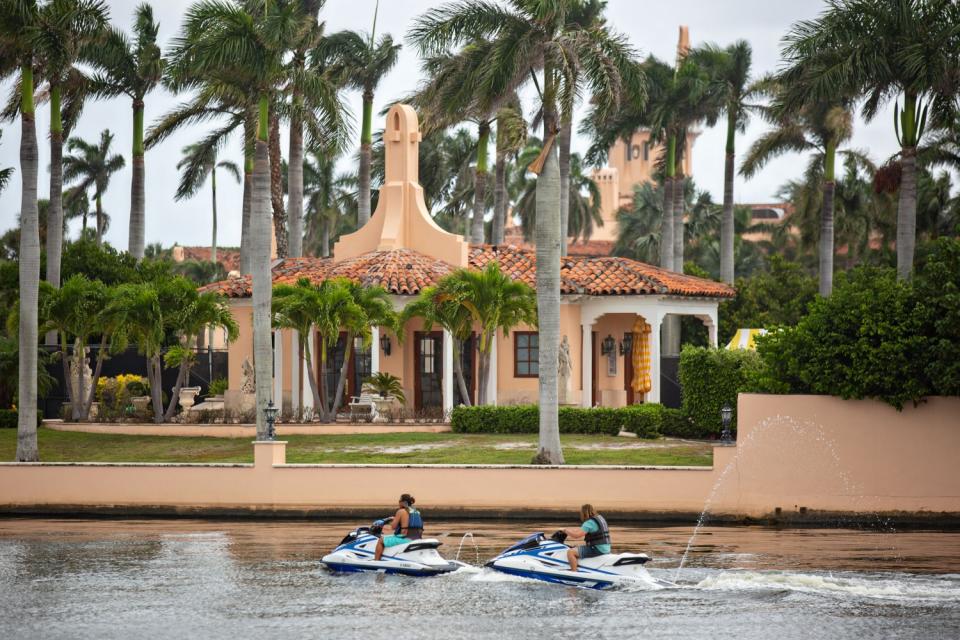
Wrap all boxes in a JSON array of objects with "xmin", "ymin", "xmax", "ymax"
[{"xmin": 202, "ymin": 245, "xmax": 735, "ymax": 298}]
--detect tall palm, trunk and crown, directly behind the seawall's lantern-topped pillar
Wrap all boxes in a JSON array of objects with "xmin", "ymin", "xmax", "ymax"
[{"xmin": 177, "ymin": 0, "xmax": 302, "ymax": 439}]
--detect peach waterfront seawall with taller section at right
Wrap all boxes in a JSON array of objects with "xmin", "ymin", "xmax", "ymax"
[{"xmin": 0, "ymin": 395, "xmax": 960, "ymax": 522}]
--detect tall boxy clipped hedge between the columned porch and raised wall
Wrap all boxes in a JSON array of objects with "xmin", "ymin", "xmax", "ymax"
[{"xmin": 672, "ymin": 346, "xmax": 760, "ymax": 434}]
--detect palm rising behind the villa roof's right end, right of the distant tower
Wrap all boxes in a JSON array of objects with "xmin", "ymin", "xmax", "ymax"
[{"xmin": 690, "ymin": 40, "xmax": 758, "ymax": 284}]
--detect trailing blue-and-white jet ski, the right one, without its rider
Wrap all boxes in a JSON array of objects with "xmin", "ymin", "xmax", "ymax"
[{"xmin": 486, "ymin": 531, "xmax": 672, "ymax": 589}]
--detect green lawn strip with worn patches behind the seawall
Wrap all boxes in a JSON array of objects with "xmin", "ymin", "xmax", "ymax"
[{"xmin": 0, "ymin": 429, "xmax": 713, "ymax": 466}]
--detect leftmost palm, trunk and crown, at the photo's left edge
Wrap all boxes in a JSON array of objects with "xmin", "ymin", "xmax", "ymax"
[{"xmin": 0, "ymin": 0, "xmax": 40, "ymax": 462}]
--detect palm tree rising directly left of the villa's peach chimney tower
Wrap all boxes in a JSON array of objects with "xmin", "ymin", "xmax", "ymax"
[{"xmin": 320, "ymin": 8, "xmax": 401, "ymax": 228}]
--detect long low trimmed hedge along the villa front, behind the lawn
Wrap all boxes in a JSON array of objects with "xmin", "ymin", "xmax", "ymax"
[{"xmin": 450, "ymin": 404, "xmax": 680, "ymax": 438}]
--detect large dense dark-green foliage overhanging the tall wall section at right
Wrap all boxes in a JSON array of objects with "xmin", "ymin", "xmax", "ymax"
[{"xmin": 757, "ymin": 239, "xmax": 960, "ymax": 409}]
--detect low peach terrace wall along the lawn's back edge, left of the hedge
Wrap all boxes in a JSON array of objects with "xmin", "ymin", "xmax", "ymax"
[{"xmin": 43, "ymin": 420, "xmax": 450, "ymax": 438}]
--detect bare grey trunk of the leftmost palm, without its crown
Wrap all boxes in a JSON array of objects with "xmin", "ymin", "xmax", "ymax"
[{"xmin": 17, "ymin": 65, "xmax": 40, "ymax": 462}]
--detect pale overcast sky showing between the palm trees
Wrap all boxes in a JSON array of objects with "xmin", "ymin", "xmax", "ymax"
[{"xmin": 0, "ymin": 0, "xmax": 896, "ymax": 249}]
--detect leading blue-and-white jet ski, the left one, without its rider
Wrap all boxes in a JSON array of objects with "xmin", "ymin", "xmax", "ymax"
[{"xmin": 323, "ymin": 518, "xmax": 466, "ymax": 577}]
